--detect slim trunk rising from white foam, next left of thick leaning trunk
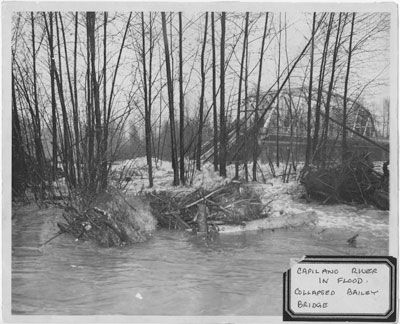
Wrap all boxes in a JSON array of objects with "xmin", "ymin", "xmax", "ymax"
[{"xmin": 141, "ymin": 12, "xmax": 153, "ymax": 188}]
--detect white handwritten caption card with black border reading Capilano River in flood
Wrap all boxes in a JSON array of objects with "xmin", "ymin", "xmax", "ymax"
[{"xmin": 284, "ymin": 257, "xmax": 396, "ymax": 321}]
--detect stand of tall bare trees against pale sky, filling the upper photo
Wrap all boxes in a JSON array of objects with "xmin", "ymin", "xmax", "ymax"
[{"xmin": 11, "ymin": 12, "xmax": 389, "ymax": 197}]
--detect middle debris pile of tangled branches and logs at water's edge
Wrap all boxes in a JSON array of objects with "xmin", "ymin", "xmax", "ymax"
[{"xmin": 147, "ymin": 181, "xmax": 267, "ymax": 229}]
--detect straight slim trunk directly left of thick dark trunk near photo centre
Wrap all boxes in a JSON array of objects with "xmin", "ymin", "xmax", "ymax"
[{"xmin": 211, "ymin": 12, "xmax": 219, "ymax": 171}]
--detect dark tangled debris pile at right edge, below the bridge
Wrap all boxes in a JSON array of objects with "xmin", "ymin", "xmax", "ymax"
[{"xmin": 300, "ymin": 155, "xmax": 389, "ymax": 210}]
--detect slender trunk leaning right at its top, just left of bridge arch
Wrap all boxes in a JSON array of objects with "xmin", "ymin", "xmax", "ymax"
[{"xmin": 253, "ymin": 12, "xmax": 268, "ymax": 181}]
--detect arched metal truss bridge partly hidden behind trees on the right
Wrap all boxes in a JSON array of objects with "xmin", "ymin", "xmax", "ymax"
[{"xmin": 202, "ymin": 88, "xmax": 389, "ymax": 162}]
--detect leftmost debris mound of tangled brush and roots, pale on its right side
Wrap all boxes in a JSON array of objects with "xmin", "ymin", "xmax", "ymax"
[{"xmin": 57, "ymin": 190, "xmax": 157, "ymax": 247}]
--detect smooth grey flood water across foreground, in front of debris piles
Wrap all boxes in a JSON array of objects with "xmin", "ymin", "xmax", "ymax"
[{"xmin": 12, "ymin": 206, "xmax": 388, "ymax": 316}]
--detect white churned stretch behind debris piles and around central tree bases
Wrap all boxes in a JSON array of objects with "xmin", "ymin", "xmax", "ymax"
[{"xmin": 109, "ymin": 158, "xmax": 389, "ymax": 233}]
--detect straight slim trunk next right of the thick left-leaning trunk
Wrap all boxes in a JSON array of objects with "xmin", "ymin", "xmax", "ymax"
[{"xmin": 179, "ymin": 12, "xmax": 186, "ymax": 184}]
